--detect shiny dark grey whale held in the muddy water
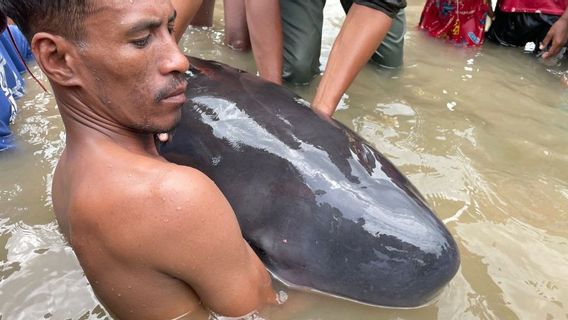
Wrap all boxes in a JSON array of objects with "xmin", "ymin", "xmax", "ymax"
[{"xmin": 160, "ymin": 58, "xmax": 460, "ymax": 307}]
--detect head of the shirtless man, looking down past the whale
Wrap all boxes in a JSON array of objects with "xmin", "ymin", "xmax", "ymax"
[{"xmin": 0, "ymin": 0, "xmax": 188, "ymax": 133}]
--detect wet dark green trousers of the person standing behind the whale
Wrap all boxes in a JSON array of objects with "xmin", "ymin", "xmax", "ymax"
[{"xmin": 280, "ymin": 0, "xmax": 406, "ymax": 84}]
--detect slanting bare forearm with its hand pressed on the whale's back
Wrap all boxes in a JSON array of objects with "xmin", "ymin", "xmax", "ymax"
[{"xmin": 312, "ymin": 4, "xmax": 392, "ymax": 116}]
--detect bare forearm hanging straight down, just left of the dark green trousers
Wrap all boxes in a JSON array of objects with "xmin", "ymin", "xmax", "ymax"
[{"xmin": 246, "ymin": 0, "xmax": 283, "ymax": 84}]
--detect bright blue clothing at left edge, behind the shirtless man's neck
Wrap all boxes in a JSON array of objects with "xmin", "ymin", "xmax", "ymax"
[{"xmin": 0, "ymin": 25, "xmax": 33, "ymax": 151}]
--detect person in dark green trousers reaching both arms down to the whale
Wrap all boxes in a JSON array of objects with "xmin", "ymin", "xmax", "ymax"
[{"xmin": 174, "ymin": 0, "xmax": 406, "ymax": 116}]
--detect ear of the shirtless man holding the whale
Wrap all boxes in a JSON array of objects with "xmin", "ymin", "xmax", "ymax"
[{"xmin": 31, "ymin": 32, "xmax": 82, "ymax": 87}]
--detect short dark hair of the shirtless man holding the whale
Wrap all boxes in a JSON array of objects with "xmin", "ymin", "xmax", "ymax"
[{"xmin": 0, "ymin": 0, "xmax": 94, "ymax": 42}]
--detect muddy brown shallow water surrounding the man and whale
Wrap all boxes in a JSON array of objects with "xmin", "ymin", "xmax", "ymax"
[{"xmin": 0, "ymin": 0, "xmax": 568, "ymax": 320}]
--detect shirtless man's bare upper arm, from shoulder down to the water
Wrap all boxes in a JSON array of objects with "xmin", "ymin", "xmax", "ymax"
[{"xmin": 151, "ymin": 167, "xmax": 276, "ymax": 317}]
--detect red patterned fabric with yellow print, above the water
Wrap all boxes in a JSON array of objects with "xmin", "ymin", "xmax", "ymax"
[{"xmin": 420, "ymin": 0, "xmax": 489, "ymax": 46}]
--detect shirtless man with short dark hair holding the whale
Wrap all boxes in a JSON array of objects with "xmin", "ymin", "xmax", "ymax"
[{"xmin": 0, "ymin": 0, "xmax": 275, "ymax": 319}]
